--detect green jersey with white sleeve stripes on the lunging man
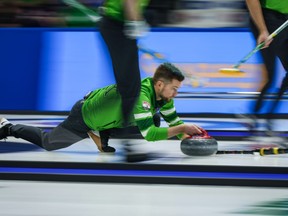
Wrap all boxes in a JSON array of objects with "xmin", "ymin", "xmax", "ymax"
[{"xmin": 82, "ymin": 78, "xmax": 183, "ymax": 141}]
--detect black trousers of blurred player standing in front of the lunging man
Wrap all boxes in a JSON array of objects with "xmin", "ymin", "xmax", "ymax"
[{"xmin": 99, "ymin": 16, "xmax": 141, "ymax": 127}]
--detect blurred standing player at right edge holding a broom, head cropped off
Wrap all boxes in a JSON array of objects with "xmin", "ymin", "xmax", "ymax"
[{"xmin": 246, "ymin": 0, "xmax": 288, "ymax": 135}]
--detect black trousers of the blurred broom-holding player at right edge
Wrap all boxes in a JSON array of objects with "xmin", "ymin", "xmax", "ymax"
[{"xmin": 250, "ymin": 9, "xmax": 288, "ymax": 119}]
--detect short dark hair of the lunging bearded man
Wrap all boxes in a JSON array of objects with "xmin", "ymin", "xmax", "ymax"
[{"xmin": 153, "ymin": 62, "xmax": 185, "ymax": 83}]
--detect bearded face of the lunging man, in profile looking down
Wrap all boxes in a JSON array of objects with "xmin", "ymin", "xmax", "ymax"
[{"xmin": 158, "ymin": 79, "xmax": 181, "ymax": 102}]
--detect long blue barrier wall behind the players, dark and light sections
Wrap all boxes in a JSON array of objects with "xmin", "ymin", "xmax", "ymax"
[{"xmin": 0, "ymin": 28, "xmax": 284, "ymax": 113}]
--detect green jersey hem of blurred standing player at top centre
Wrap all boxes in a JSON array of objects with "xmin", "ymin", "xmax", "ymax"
[{"xmin": 104, "ymin": 0, "xmax": 150, "ymax": 21}]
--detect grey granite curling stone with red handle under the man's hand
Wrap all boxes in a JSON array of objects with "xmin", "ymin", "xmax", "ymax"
[{"xmin": 180, "ymin": 129, "xmax": 218, "ymax": 156}]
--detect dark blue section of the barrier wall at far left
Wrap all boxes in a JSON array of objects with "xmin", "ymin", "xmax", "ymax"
[{"xmin": 0, "ymin": 28, "xmax": 42, "ymax": 110}]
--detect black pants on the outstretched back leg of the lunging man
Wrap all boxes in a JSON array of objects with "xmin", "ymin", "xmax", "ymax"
[{"xmin": 10, "ymin": 100, "xmax": 90, "ymax": 151}]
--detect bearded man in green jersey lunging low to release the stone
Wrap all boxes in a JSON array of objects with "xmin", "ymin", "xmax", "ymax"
[{"xmin": 0, "ymin": 63, "xmax": 202, "ymax": 156}]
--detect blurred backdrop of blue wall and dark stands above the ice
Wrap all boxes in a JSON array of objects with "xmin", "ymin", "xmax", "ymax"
[{"xmin": 0, "ymin": 0, "xmax": 286, "ymax": 113}]
